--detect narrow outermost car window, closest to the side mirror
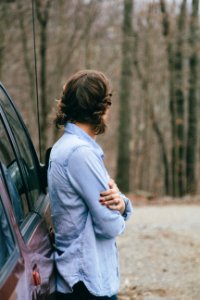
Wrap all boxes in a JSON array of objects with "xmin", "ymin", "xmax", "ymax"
[{"xmin": 0, "ymin": 88, "xmax": 40, "ymax": 204}]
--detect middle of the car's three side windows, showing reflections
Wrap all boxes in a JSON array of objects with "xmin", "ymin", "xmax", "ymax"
[{"xmin": 0, "ymin": 118, "xmax": 29, "ymax": 225}]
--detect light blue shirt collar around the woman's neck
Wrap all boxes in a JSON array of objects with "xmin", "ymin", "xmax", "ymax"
[{"xmin": 64, "ymin": 122, "xmax": 104, "ymax": 159}]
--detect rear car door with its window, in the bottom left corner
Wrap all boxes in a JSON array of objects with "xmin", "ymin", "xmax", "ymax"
[{"xmin": 0, "ymin": 171, "xmax": 26, "ymax": 300}]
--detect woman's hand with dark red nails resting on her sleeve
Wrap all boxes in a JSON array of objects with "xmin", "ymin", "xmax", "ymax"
[{"xmin": 99, "ymin": 179, "xmax": 125, "ymax": 215}]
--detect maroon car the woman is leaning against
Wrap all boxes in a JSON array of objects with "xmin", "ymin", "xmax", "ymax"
[{"xmin": 0, "ymin": 83, "xmax": 55, "ymax": 300}]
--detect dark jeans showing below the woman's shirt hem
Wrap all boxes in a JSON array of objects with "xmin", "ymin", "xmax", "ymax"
[{"xmin": 56, "ymin": 281, "xmax": 117, "ymax": 300}]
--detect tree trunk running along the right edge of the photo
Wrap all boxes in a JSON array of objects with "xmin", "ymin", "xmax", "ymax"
[{"xmin": 186, "ymin": 0, "xmax": 199, "ymax": 194}]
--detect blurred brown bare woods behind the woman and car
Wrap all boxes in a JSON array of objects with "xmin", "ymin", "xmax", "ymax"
[{"xmin": 0, "ymin": 0, "xmax": 200, "ymax": 197}]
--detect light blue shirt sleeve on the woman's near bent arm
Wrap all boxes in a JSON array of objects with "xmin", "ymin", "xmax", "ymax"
[{"xmin": 66, "ymin": 146, "xmax": 125, "ymax": 238}]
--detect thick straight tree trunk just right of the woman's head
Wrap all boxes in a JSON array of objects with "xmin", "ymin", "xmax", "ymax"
[{"xmin": 117, "ymin": 0, "xmax": 133, "ymax": 192}]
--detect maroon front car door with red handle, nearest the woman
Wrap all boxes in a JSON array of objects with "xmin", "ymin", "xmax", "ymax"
[{"xmin": 0, "ymin": 85, "xmax": 55, "ymax": 300}]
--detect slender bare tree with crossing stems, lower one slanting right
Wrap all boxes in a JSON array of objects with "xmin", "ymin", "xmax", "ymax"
[{"xmin": 133, "ymin": 3, "xmax": 170, "ymax": 195}]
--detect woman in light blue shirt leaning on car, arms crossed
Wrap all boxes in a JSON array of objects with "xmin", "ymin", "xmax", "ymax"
[{"xmin": 48, "ymin": 70, "xmax": 132, "ymax": 300}]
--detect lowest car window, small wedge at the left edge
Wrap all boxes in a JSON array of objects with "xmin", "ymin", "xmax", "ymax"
[{"xmin": 0, "ymin": 194, "xmax": 15, "ymax": 272}]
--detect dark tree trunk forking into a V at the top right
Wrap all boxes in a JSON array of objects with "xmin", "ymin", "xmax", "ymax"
[{"xmin": 160, "ymin": 0, "xmax": 186, "ymax": 196}]
